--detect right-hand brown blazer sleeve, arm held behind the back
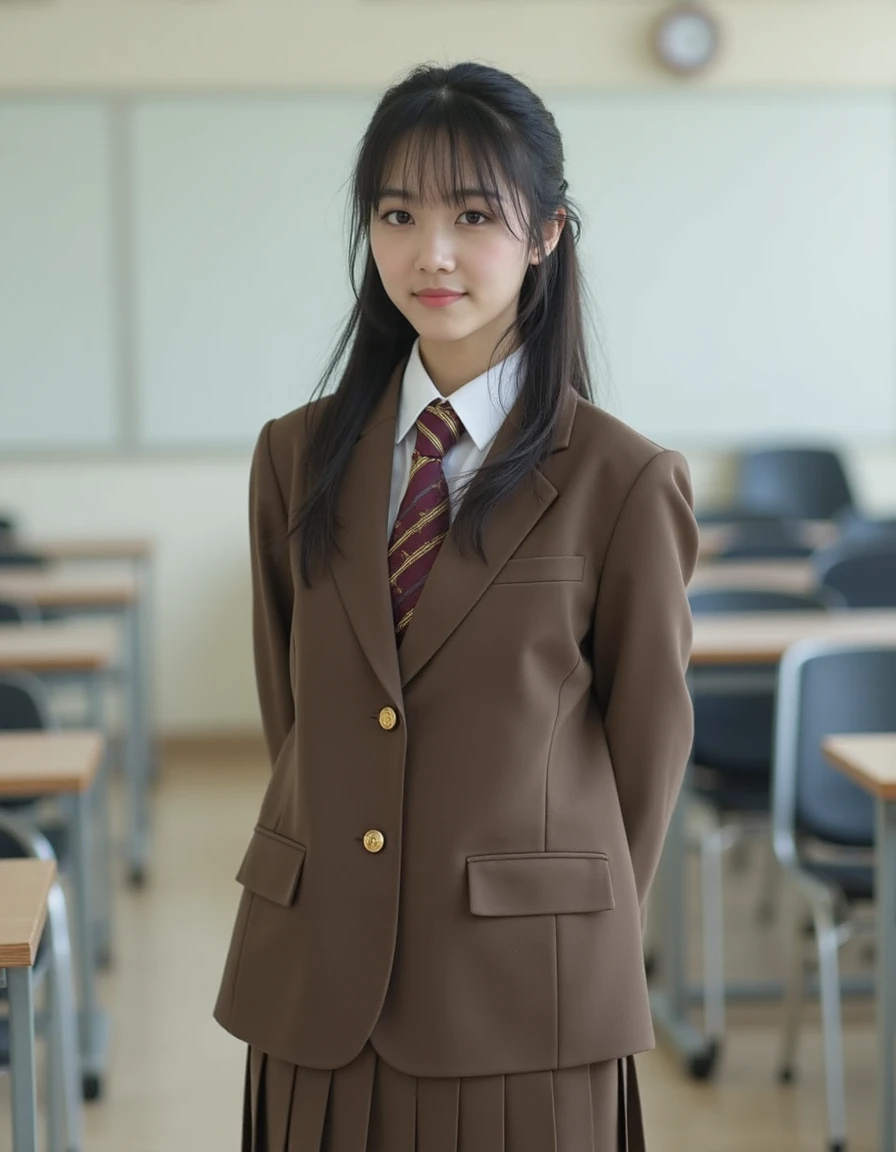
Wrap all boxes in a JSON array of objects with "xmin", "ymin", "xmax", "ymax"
[{"xmin": 593, "ymin": 452, "xmax": 698, "ymax": 922}]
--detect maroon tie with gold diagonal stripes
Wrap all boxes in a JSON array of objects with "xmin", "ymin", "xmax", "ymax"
[{"xmin": 389, "ymin": 400, "xmax": 464, "ymax": 645}]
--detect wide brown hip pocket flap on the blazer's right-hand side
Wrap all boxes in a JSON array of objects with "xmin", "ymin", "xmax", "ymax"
[{"xmin": 466, "ymin": 852, "xmax": 616, "ymax": 916}]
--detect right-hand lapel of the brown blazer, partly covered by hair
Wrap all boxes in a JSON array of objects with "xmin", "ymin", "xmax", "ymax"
[{"xmin": 393, "ymin": 387, "xmax": 576, "ymax": 687}]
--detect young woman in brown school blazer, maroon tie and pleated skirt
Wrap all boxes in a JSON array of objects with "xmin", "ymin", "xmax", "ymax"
[{"xmin": 215, "ymin": 63, "xmax": 697, "ymax": 1152}]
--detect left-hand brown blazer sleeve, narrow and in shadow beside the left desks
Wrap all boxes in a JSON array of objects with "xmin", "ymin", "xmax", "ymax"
[{"xmin": 249, "ymin": 420, "xmax": 295, "ymax": 765}]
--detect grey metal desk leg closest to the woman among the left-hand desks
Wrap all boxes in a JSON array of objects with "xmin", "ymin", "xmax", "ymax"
[{"xmin": 124, "ymin": 605, "xmax": 150, "ymax": 887}]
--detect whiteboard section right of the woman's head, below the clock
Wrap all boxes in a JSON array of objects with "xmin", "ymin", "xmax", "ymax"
[{"xmin": 549, "ymin": 93, "xmax": 896, "ymax": 445}]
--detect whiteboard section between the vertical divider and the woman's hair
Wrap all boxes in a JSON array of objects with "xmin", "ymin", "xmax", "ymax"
[{"xmin": 131, "ymin": 96, "xmax": 373, "ymax": 446}]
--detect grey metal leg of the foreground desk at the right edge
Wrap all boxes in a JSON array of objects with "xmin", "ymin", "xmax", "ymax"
[{"xmin": 875, "ymin": 799, "xmax": 896, "ymax": 1152}]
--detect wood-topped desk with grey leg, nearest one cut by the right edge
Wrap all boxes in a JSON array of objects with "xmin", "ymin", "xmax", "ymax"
[{"xmin": 821, "ymin": 733, "xmax": 896, "ymax": 1152}]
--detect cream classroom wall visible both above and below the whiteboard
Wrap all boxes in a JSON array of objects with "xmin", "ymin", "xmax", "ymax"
[{"xmin": 0, "ymin": 0, "xmax": 896, "ymax": 734}]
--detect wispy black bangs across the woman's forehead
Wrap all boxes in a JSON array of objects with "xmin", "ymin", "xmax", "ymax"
[{"xmin": 356, "ymin": 94, "xmax": 534, "ymax": 234}]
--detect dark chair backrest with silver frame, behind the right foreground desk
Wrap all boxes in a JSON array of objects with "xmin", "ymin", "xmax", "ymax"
[{"xmin": 773, "ymin": 641, "xmax": 896, "ymax": 863}]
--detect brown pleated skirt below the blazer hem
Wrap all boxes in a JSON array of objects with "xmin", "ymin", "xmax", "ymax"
[{"xmin": 243, "ymin": 1044, "xmax": 643, "ymax": 1152}]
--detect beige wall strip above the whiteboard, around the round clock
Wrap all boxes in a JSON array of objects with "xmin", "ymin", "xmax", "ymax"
[{"xmin": 0, "ymin": 0, "xmax": 896, "ymax": 91}]
